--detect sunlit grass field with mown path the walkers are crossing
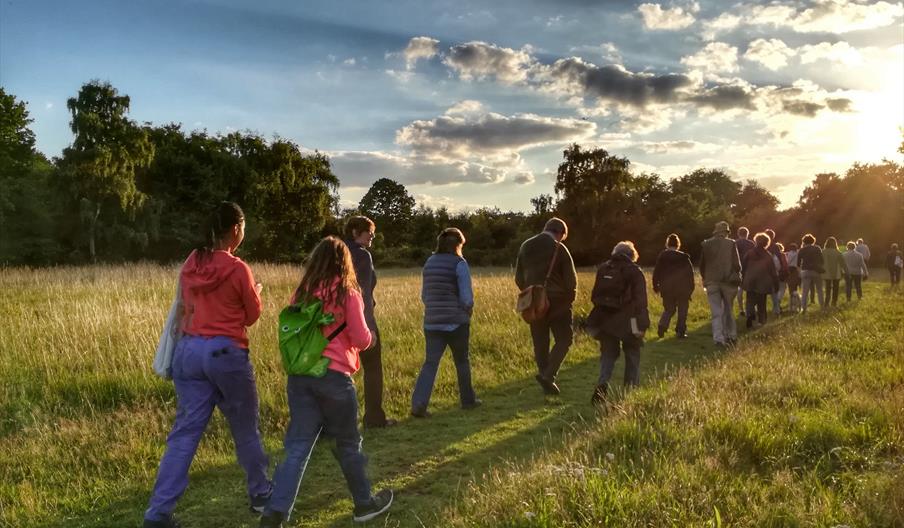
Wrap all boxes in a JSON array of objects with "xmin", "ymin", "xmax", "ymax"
[{"xmin": 0, "ymin": 265, "xmax": 904, "ymax": 528}]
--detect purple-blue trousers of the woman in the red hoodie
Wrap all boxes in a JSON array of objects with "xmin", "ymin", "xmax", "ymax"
[{"xmin": 144, "ymin": 336, "xmax": 270, "ymax": 521}]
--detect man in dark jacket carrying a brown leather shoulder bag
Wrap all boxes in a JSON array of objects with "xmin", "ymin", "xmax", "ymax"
[{"xmin": 515, "ymin": 218, "xmax": 578, "ymax": 394}]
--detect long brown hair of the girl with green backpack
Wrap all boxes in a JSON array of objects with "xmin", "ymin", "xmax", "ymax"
[{"xmin": 292, "ymin": 236, "xmax": 361, "ymax": 304}]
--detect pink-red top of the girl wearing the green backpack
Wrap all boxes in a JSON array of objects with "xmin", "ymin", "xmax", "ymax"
[{"xmin": 291, "ymin": 279, "xmax": 371, "ymax": 375}]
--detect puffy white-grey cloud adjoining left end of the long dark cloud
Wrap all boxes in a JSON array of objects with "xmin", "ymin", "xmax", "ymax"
[{"xmin": 443, "ymin": 41, "xmax": 534, "ymax": 84}]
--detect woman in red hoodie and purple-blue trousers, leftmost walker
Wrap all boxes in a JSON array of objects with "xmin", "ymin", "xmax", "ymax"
[{"xmin": 144, "ymin": 202, "xmax": 270, "ymax": 528}]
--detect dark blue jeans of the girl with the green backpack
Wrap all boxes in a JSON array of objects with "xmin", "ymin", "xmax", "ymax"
[{"xmin": 265, "ymin": 369, "xmax": 372, "ymax": 520}]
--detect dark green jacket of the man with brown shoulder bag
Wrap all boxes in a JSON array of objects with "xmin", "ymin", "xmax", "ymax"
[{"xmin": 515, "ymin": 233, "xmax": 578, "ymax": 303}]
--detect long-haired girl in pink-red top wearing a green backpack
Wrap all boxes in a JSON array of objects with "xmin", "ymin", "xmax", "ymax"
[{"xmin": 260, "ymin": 237, "xmax": 393, "ymax": 527}]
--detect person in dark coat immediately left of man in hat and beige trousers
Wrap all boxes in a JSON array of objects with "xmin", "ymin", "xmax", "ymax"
[{"xmin": 653, "ymin": 233, "xmax": 694, "ymax": 338}]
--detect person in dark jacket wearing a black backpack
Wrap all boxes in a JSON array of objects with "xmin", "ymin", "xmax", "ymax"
[{"xmin": 587, "ymin": 241, "xmax": 650, "ymax": 403}]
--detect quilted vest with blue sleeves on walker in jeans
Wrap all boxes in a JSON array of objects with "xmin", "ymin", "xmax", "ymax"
[{"xmin": 421, "ymin": 253, "xmax": 474, "ymax": 332}]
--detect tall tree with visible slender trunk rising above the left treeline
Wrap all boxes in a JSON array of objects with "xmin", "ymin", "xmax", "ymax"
[{"xmin": 61, "ymin": 80, "xmax": 154, "ymax": 261}]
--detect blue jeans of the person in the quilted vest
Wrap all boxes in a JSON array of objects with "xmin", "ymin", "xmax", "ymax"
[{"xmin": 411, "ymin": 324, "xmax": 477, "ymax": 409}]
